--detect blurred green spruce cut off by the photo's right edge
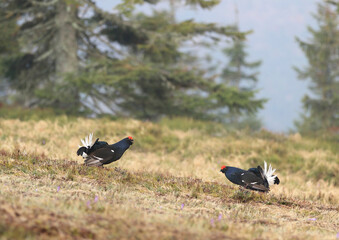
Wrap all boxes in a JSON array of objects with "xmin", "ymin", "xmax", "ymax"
[{"xmin": 295, "ymin": 3, "xmax": 339, "ymax": 132}]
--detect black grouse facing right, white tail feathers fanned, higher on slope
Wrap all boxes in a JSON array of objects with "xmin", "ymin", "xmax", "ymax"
[{"xmin": 77, "ymin": 133, "xmax": 133, "ymax": 166}]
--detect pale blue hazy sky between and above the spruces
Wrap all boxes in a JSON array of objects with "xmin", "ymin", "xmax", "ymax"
[{"xmin": 97, "ymin": 0, "xmax": 319, "ymax": 132}]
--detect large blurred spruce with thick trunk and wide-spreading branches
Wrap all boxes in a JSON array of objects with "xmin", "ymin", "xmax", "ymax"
[{"xmin": 2, "ymin": 0, "xmax": 264, "ymax": 119}]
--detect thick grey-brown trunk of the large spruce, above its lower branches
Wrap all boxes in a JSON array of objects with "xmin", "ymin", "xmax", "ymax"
[{"xmin": 55, "ymin": 0, "xmax": 78, "ymax": 76}]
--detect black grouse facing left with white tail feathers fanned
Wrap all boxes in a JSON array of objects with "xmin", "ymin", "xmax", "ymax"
[{"xmin": 220, "ymin": 162, "xmax": 280, "ymax": 192}]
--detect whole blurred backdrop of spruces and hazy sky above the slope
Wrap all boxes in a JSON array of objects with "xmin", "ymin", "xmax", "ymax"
[{"xmin": 0, "ymin": 0, "xmax": 339, "ymax": 134}]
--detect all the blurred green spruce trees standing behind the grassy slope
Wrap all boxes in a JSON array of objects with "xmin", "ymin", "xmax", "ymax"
[{"xmin": 0, "ymin": 0, "xmax": 339, "ymax": 132}]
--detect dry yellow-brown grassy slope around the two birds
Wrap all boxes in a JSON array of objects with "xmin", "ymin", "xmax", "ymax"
[{"xmin": 0, "ymin": 117, "xmax": 339, "ymax": 239}]
